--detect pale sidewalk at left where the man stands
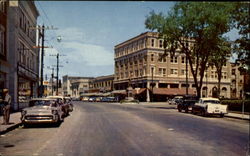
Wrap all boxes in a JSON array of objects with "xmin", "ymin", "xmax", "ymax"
[{"xmin": 0, "ymin": 112, "xmax": 21, "ymax": 135}]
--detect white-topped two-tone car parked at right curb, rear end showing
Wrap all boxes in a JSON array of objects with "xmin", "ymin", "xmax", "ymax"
[{"xmin": 192, "ymin": 98, "xmax": 228, "ymax": 117}]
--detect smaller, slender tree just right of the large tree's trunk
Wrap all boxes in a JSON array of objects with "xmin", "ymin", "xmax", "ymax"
[{"xmin": 208, "ymin": 38, "xmax": 231, "ymax": 97}]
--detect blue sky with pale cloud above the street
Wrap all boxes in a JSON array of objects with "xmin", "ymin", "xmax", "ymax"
[{"xmin": 35, "ymin": 1, "xmax": 237, "ymax": 78}]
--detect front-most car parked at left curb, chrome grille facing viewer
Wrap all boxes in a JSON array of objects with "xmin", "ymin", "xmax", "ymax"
[{"xmin": 21, "ymin": 98, "xmax": 63, "ymax": 126}]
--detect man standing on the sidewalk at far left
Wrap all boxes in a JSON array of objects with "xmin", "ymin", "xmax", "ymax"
[{"xmin": 3, "ymin": 89, "xmax": 11, "ymax": 125}]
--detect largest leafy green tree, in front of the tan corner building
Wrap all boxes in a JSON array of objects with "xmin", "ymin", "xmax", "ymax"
[{"xmin": 145, "ymin": 2, "xmax": 232, "ymax": 97}]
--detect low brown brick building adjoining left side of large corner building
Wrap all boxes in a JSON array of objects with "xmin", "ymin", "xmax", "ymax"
[{"xmin": 92, "ymin": 75, "xmax": 114, "ymax": 93}]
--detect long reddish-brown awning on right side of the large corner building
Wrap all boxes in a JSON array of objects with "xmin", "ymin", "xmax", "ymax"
[{"xmin": 153, "ymin": 88, "xmax": 195, "ymax": 95}]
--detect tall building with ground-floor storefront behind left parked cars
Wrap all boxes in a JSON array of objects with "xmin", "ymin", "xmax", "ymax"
[{"xmin": 7, "ymin": 0, "xmax": 39, "ymax": 110}]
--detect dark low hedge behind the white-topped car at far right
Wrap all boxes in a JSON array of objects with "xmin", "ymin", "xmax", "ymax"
[{"xmin": 221, "ymin": 100, "xmax": 250, "ymax": 112}]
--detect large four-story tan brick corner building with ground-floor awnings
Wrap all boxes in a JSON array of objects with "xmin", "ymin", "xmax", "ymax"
[{"xmin": 114, "ymin": 32, "xmax": 231, "ymax": 101}]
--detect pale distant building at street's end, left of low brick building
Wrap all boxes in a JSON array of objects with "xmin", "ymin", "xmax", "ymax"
[{"xmin": 62, "ymin": 75, "xmax": 94, "ymax": 97}]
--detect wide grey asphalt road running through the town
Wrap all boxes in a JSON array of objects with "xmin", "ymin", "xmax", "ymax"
[{"xmin": 0, "ymin": 102, "xmax": 249, "ymax": 156}]
